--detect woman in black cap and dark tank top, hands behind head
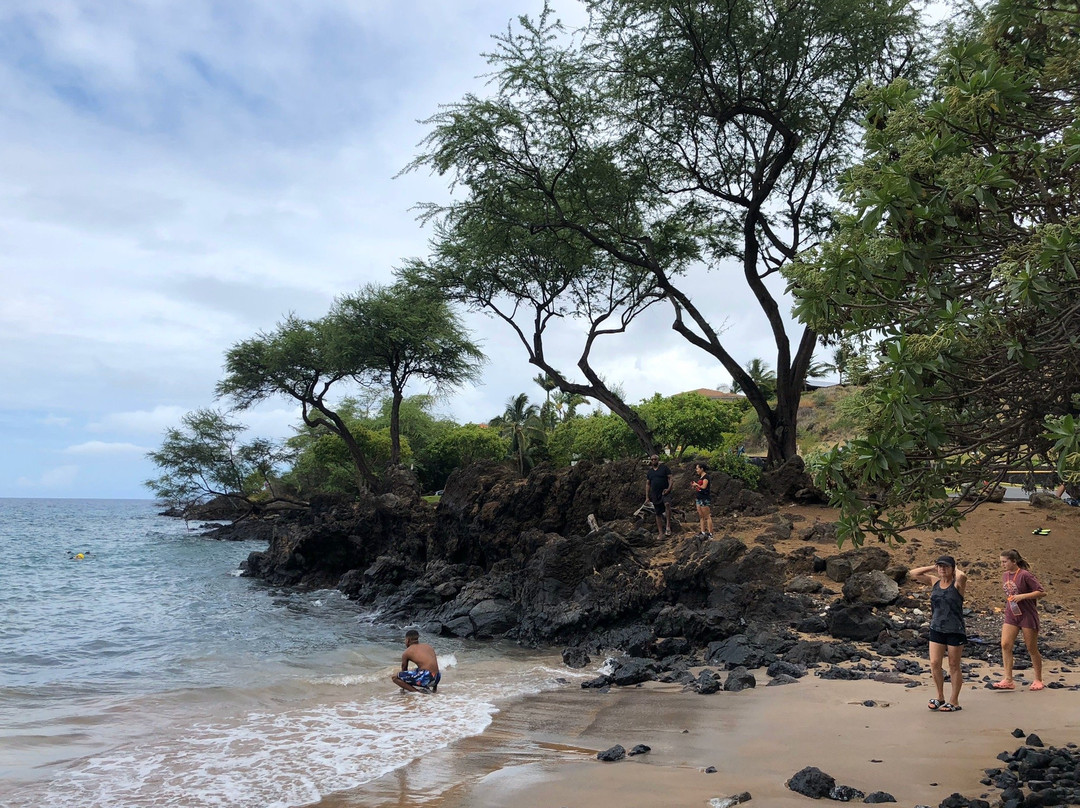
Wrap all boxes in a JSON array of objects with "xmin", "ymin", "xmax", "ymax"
[{"xmin": 907, "ymin": 555, "xmax": 968, "ymax": 713}]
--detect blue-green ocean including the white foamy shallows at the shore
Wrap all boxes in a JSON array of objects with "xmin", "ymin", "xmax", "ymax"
[{"xmin": 0, "ymin": 499, "xmax": 575, "ymax": 808}]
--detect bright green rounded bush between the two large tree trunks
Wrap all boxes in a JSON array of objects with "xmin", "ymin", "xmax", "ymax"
[{"xmin": 637, "ymin": 393, "xmax": 748, "ymax": 457}]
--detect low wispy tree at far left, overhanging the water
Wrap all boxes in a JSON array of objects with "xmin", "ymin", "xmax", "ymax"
[{"xmin": 144, "ymin": 409, "xmax": 294, "ymax": 515}]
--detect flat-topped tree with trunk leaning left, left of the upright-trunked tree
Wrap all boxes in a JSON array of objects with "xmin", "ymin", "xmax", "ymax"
[{"xmin": 217, "ymin": 314, "xmax": 378, "ymax": 490}]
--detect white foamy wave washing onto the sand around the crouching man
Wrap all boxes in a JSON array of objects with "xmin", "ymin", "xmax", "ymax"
[{"xmin": 3, "ymin": 655, "xmax": 577, "ymax": 808}]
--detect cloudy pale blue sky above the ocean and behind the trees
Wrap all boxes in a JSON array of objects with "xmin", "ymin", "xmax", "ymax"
[{"xmin": 0, "ymin": 0, "xmax": 820, "ymax": 498}]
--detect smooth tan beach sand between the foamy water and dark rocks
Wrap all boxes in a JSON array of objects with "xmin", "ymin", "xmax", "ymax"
[{"xmin": 318, "ymin": 663, "xmax": 1080, "ymax": 808}]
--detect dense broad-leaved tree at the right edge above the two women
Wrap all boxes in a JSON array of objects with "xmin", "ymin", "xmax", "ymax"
[{"xmin": 789, "ymin": 0, "xmax": 1080, "ymax": 543}]
